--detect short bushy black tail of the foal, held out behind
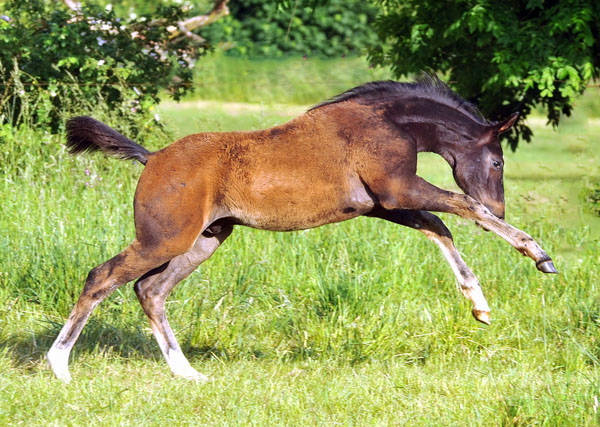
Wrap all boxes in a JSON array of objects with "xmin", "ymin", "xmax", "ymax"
[{"xmin": 67, "ymin": 116, "xmax": 152, "ymax": 165}]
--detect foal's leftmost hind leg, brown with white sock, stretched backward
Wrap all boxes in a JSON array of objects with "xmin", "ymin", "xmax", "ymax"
[{"xmin": 47, "ymin": 240, "xmax": 173, "ymax": 382}]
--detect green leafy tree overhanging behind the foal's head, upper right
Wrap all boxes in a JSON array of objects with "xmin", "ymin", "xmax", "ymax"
[{"xmin": 370, "ymin": 0, "xmax": 600, "ymax": 149}]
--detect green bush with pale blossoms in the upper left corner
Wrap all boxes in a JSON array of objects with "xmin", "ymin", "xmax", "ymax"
[{"xmin": 0, "ymin": 0, "xmax": 204, "ymax": 131}]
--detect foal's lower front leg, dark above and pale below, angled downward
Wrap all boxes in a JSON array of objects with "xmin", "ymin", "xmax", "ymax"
[{"xmin": 369, "ymin": 209, "xmax": 490, "ymax": 325}]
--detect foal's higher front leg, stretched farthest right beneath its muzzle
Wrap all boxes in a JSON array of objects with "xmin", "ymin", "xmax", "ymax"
[{"xmin": 371, "ymin": 175, "xmax": 557, "ymax": 273}]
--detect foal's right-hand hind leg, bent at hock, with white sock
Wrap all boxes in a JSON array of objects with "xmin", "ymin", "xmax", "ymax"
[{"xmin": 134, "ymin": 226, "xmax": 233, "ymax": 381}]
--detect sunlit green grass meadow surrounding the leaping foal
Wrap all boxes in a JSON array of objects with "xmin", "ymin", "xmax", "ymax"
[{"xmin": 0, "ymin": 59, "xmax": 600, "ymax": 426}]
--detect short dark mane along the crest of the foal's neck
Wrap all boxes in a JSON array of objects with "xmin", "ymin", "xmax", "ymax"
[{"xmin": 308, "ymin": 74, "xmax": 489, "ymax": 124}]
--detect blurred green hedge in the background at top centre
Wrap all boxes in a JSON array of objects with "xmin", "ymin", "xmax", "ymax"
[{"xmin": 202, "ymin": 0, "xmax": 377, "ymax": 57}]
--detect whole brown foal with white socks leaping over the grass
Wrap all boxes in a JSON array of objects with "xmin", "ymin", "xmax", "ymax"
[{"xmin": 48, "ymin": 77, "xmax": 556, "ymax": 381}]
